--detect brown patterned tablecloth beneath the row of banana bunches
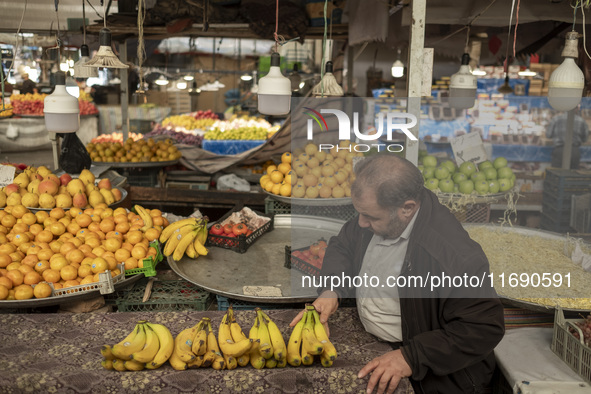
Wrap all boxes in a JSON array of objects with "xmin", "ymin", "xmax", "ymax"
[{"xmin": 0, "ymin": 308, "xmax": 413, "ymax": 394}]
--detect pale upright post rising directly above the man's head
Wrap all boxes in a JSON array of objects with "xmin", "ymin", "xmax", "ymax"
[{"xmin": 405, "ymin": 0, "xmax": 427, "ymax": 165}]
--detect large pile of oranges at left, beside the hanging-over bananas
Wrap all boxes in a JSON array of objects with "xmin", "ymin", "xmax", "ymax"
[{"xmin": 0, "ymin": 204, "xmax": 168, "ymax": 300}]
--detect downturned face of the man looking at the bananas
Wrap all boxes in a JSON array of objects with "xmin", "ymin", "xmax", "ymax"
[{"xmin": 352, "ymin": 191, "xmax": 412, "ymax": 239}]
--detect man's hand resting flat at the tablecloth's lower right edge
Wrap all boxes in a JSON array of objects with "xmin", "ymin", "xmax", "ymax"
[{"xmin": 357, "ymin": 350, "xmax": 412, "ymax": 394}]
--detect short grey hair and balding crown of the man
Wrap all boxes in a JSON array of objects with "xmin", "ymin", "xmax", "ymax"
[{"xmin": 351, "ymin": 153, "xmax": 424, "ymax": 208}]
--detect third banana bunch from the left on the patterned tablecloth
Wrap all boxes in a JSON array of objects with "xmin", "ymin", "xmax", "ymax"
[{"xmin": 218, "ymin": 307, "xmax": 253, "ymax": 369}]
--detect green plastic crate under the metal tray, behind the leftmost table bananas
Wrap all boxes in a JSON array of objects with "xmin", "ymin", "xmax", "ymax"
[{"xmin": 117, "ymin": 280, "xmax": 213, "ymax": 312}]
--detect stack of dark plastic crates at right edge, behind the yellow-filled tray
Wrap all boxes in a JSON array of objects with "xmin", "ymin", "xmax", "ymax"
[{"xmin": 541, "ymin": 168, "xmax": 591, "ymax": 233}]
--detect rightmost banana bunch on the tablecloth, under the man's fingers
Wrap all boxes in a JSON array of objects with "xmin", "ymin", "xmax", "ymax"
[{"xmin": 287, "ymin": 305, "xmax": 337, "ymax": 367}]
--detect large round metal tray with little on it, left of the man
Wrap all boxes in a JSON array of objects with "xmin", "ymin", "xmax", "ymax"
[{"xmin": 168, "ymin": 215, "xmax": 344, "ymax": 303}]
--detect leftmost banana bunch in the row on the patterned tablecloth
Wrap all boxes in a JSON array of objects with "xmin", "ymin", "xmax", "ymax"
[{"xmin": 101, "ymin": 321, "xmax": 174, "ymax": 371}]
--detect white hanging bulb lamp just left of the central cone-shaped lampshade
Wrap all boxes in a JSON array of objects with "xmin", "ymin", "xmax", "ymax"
[{"xmin": 257, "ymin": 52, "xmax": 291, "ymax": 115}]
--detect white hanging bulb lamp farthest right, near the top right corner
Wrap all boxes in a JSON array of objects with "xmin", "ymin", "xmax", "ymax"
[{"xmin": 548, "ymin": 31, "xmax": 585, "ymax": 111}]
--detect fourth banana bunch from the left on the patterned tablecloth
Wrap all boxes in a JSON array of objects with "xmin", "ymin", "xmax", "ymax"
[{"xmin": 249, "ymin": 308, "xmax": 287, "ymax": 369}]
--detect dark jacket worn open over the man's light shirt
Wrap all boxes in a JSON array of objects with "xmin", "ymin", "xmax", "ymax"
[{"xmin": 321, "ymin": 189, "xmax": 505, "ymax": 394}]
